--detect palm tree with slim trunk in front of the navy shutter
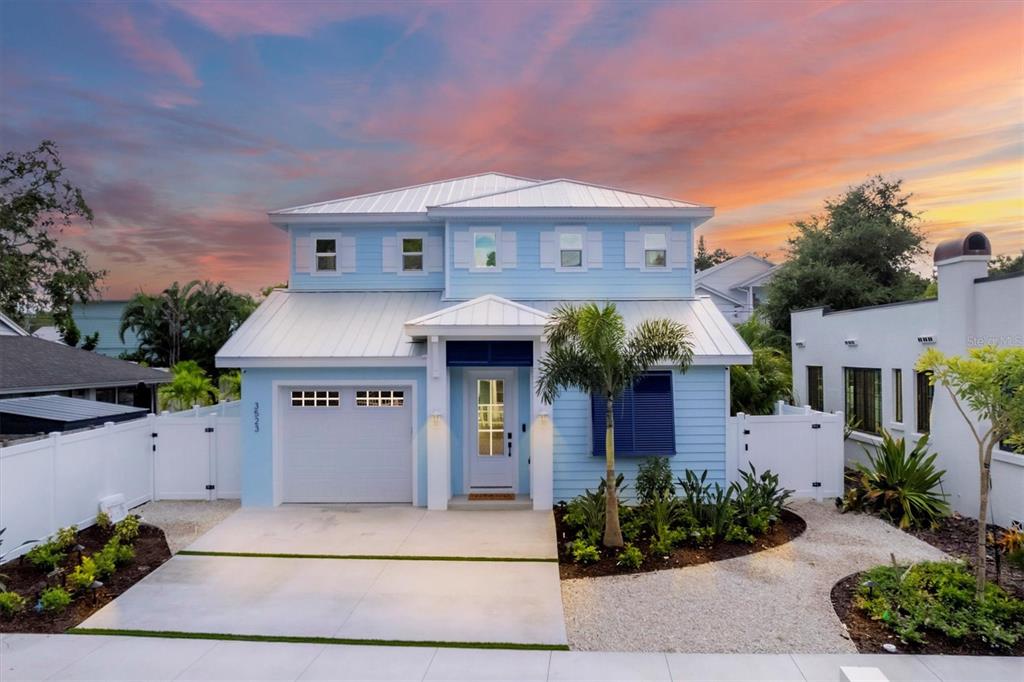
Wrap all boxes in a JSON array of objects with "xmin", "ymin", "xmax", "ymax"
[{"xmin": 538, "ymin": 303, "xmax": 693, "ymax": 547}]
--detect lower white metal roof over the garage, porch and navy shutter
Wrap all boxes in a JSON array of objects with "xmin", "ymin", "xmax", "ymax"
[{"xmin": 217, "ymin": 291, "xmax": 751, "ymax": 367}]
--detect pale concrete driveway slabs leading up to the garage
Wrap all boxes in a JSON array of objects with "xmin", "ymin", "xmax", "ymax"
[{"xmin": 80, "ymin": 505, "xmax": 567, "ymax": 646}]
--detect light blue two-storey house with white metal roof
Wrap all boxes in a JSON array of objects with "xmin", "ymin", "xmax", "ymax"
[{"xmin": 217, "ymin": 173, "xmax": 751, "ymax": 509}]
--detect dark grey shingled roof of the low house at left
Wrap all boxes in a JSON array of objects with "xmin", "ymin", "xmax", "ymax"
[{"xmin": 0, "ymin": 314, "xmax": 171, "ymax": 411}]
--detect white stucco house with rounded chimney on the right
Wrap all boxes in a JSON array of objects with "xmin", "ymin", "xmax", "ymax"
[{"xmin": 791, "ymin": 232, "xmax": 1024, "ymax": 523}]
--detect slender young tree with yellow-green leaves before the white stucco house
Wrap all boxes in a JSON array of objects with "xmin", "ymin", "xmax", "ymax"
[{"xmin": 916, "ymin": 346, "xmax": 1024, "ymax": 601}]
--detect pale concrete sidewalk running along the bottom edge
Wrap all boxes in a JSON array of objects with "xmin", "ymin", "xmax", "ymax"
[{"xmin": 0, "ymin": 635, "xmax": 1024, "ymax": 682}]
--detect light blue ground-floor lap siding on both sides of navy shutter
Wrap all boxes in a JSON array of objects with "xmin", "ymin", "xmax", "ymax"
[{"xmin": 552, "ymin": 367, "xmax": 726, "ymax": 501}]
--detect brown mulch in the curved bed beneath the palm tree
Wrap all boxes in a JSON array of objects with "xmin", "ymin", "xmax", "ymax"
[{"xmin": 555, "ymin": 507, "xmax": 807, "ymax": 581}]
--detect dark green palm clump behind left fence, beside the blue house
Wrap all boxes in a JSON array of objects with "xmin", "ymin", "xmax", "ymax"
[{"xmin": 120, "ymin": 281, "xmax": 256, "ymax": 372}]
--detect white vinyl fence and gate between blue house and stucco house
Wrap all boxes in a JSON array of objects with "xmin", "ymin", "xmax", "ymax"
[{"xmin": 726, "ymin": 402, "xmax": 846, "ymax": 502}]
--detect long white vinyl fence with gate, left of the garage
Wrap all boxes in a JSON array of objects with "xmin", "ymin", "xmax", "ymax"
[{"xmin": 0, "ymin": 403, "xmax": 242, "ymax": 561}]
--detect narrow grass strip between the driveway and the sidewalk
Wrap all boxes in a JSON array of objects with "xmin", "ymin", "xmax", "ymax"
[{"xmin": 66, "ymin": 628, "xmax": 569, "ymax": 651}]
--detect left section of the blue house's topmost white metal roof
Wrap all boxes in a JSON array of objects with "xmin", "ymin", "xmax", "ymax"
[{"xmin": 270, "ymin": 173, "xmax": 537, "ymax": 215}]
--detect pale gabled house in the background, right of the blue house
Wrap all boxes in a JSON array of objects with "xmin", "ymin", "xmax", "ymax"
[{"xmin": 693, "ymin": 253, "xmax": 778, "ymax": 325}]
